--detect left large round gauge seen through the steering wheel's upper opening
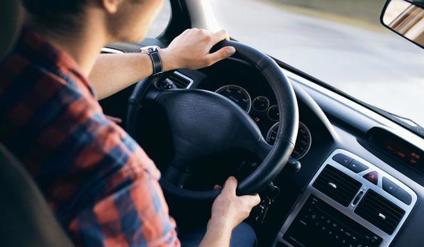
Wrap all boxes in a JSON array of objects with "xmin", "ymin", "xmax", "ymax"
[{"xmin": 215, "ymin": 85, "xmax": 252, "ymax": 113}]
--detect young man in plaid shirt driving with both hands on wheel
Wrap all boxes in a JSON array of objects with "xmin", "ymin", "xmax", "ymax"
[{"xmin": 0, "ymin": 0, "xmax": 260, "ymax": 246}]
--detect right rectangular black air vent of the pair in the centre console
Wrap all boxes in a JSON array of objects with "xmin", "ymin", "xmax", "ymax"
[{"xmin": 355, "ymin": 190, "xmax": 405, "ymax": 235}]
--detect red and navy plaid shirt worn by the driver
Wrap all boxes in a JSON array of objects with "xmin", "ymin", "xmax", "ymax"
[{"xmin": 0, "ymin": 30, "xmax": 180, "ymax": 246}]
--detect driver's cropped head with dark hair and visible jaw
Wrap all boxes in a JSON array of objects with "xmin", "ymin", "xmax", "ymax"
[{"xmin": 22, "ymin": 0, "xmax": 164, "ymax": 41}]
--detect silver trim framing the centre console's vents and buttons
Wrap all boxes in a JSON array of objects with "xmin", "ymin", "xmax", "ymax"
[{"xmin": 274, "ymin": 149, "xmax": 417, "ymax": 247}]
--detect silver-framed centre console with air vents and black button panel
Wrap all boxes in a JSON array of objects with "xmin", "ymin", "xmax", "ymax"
[{"xmin": 274, "ymin": 150, "xmax": 417, "ymax": 247}]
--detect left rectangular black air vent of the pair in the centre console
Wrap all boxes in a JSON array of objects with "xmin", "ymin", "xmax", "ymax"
[{"xmin": 313, "ymin": 165, "xmax": 362, "ymax": 207}]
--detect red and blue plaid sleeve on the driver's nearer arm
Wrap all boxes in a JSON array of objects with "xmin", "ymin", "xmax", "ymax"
[{"xmin": 60, "ymin": 101, "xmax": 180, "ymax": 247}]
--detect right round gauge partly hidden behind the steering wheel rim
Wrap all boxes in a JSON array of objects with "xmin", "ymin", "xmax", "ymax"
[{"xmin": 266, "ymin": 122, "xmax": 312, "ymax": 160}]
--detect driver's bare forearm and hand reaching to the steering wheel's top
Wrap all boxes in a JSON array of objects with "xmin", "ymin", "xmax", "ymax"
[{"xmin": 90, "ymin": 29, "xmax": 235, "ymax": 99}]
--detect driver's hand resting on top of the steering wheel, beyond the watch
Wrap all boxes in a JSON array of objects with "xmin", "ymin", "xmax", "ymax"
[{"xmin": 160, "ymin": 28, "xmax": 236, "ymax": 71}]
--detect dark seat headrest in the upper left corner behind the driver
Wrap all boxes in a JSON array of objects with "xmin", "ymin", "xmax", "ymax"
[{"xmin": 0, "ymin": 0, "xmax": 23, "ymax": 59}]
